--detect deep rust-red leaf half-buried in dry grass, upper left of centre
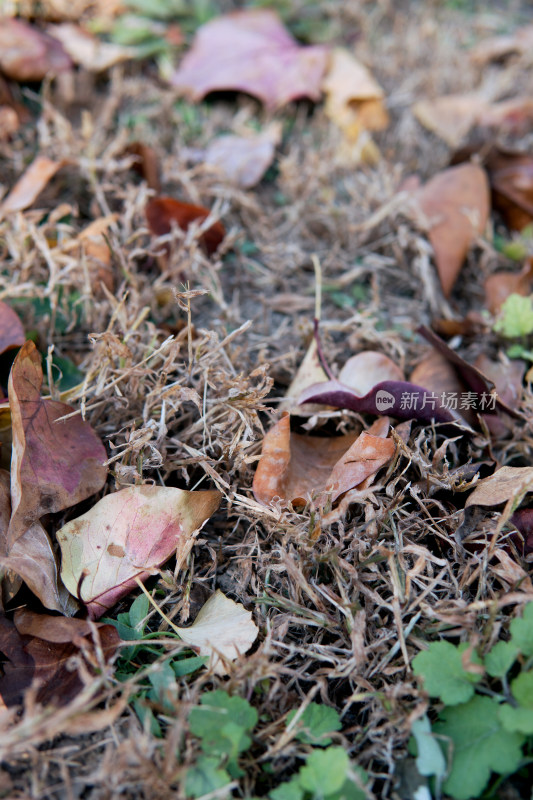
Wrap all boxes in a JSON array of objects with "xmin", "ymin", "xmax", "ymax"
[{"xmin": 145, "ymin": 197, "xmax": 226, "ymax": 255}]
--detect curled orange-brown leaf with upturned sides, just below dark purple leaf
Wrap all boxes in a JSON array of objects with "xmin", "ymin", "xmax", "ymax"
[{"xmin": 253, "ymin": 414, "xmax": 395, "ymax": 505}]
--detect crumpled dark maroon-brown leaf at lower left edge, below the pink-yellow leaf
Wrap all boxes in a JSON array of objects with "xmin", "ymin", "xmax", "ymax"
[{"xmin": 0, "ymin": 610, "xmax": 121, "ymax": 706}]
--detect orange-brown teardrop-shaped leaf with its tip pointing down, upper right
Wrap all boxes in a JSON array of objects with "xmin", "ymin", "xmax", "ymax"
[{"xmin": 415, "ymin": 164, "xmax": 490, "ymax": 297}]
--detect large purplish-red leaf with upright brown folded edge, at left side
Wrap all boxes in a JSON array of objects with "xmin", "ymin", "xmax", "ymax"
[{"xmin": 7, "ymin": 341, "xmax": 107, "ymax": 549}]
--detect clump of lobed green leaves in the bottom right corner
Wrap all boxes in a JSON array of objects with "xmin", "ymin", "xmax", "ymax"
[{"xmin": 411, "ymin": 603, "xmax": 533, "ymax": 800}]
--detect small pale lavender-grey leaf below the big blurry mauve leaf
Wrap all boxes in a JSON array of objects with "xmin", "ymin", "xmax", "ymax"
[{"xmin": 205, "ymin": 123, "xmax": 281, "ymax": 189}]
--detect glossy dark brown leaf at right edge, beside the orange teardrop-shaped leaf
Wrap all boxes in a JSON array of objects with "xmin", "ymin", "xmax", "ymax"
[{"xmin": 487, "ymin": 149, "xmax": 533, "ymax": 231}]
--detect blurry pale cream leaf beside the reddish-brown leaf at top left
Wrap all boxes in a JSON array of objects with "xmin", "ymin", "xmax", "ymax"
[{"xmin": 47, "ymin": 22, "xmax": 137, "ymax": 72}]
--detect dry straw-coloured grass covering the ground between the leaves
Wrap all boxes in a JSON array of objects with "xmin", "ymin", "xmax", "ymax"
[{"xmin": 0, "ymin": 0, "xmax": 533, "ymax": 800}]
